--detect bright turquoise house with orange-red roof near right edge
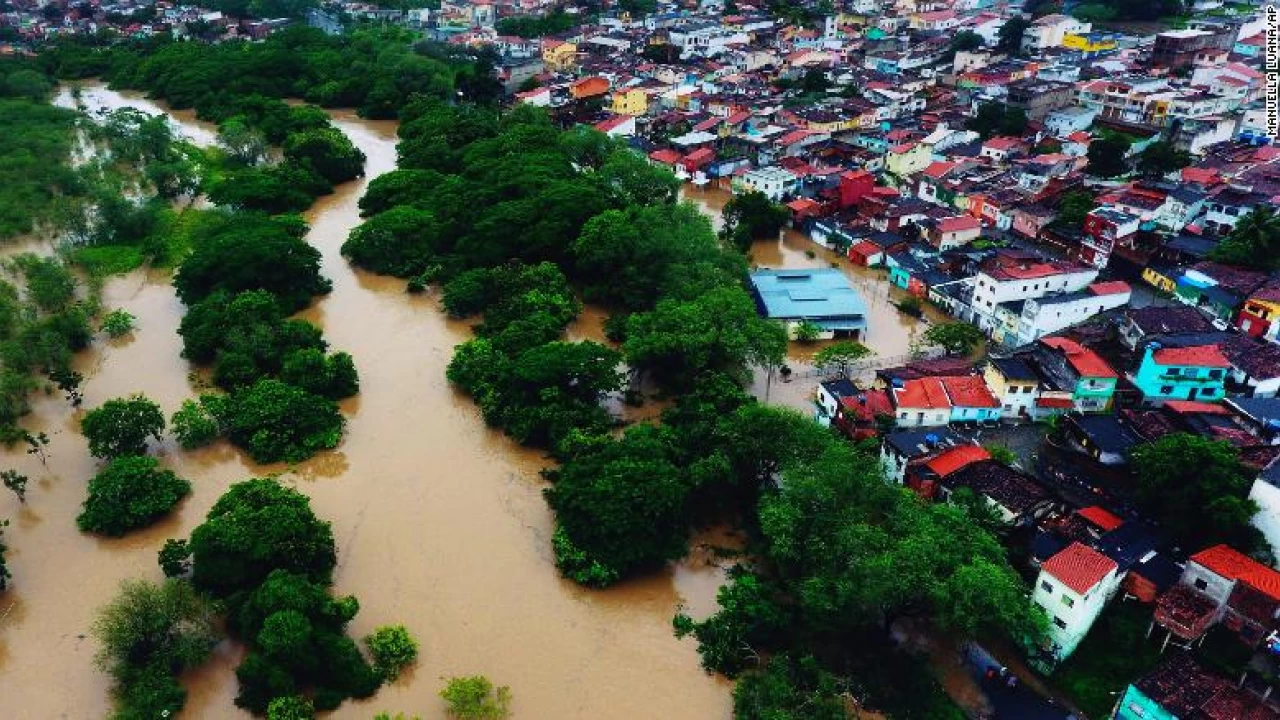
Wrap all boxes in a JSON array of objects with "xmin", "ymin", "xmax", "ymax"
[{"xmin": 1133, "ymin": 342, "xmax": 1231, "ymax": 405}]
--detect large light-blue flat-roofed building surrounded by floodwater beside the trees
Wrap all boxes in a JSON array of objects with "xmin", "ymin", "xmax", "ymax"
[{"xmin": 750, "ymin": 268, "xmax": 867, "ymax": 340}]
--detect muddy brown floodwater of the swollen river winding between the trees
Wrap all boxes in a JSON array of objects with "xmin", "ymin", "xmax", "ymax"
[{"xmin": 0, "ymin": 85, "xmax": 731, "ymax": 720}]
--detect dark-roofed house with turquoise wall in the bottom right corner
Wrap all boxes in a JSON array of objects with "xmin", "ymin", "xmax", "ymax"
[{"xmin": 1114, "ymin": 652, "xmax": 1276, "ymax": 720}]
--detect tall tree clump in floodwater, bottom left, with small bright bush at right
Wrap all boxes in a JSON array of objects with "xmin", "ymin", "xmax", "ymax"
[{"xmin": 161, "ymin": 479, "xmax": 417, "ymax": 715}]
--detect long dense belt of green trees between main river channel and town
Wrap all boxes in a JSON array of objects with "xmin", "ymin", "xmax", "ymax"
[{"xmin": 343, "ymin": 94, "xmax": 1041, "ymax": 719}]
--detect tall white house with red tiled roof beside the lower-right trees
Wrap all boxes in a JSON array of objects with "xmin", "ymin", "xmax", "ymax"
[{"xmin": 1032, "ymin": 542, "xmax": 1124, "ymax": 661}]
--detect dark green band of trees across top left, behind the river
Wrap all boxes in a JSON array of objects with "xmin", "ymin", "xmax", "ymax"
[{"xmin": 40, "ymin": 24, "xmax": 500, "ymax": 118}]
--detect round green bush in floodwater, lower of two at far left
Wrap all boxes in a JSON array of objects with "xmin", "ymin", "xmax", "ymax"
[{"xmin": 76, "ymin": 456, "xmax": 191, "ymax": 537}]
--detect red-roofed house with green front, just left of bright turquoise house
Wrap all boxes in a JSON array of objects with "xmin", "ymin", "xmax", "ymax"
[{"xmin": 1027, "ymin": 337, "xmax": 1120, "ymax": 413}]
